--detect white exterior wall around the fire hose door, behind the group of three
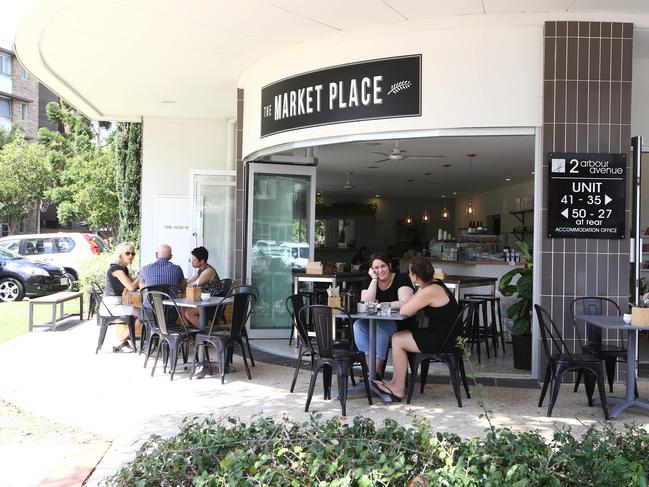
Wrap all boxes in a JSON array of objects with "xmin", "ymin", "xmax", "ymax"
[{"xmin": 141, "ymin": 118, "xmax": 234, "ymax": 267}]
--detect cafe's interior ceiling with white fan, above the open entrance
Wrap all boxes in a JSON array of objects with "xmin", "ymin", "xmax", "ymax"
[{"xmin": 316, "ymin": 135, "xmax": 534, "ymax": 198}]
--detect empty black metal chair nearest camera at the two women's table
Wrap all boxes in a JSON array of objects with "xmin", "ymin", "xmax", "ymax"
[{"xmin": 297, "ymin": 304, "xmax": 372, "ymax": 416}]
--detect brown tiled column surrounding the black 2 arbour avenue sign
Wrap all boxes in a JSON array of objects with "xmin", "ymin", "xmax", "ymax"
[{"xmin": 536, "ymin": 22, "xmax": 633, "ymax": 374}]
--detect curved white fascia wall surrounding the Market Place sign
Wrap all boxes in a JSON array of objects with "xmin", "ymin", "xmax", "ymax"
[{"xmin": 240, "ymin": 22, "xmax": 543, "ymax": 157}]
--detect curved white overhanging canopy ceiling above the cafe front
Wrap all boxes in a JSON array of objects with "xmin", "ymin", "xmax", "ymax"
[{"xmin": 15, "ymin": 0, "xmax": 649, "ymax": 120}]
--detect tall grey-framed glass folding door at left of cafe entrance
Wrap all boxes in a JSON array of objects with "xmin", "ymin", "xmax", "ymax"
[{"xmin": 247, "ymin": 163, "xmax": 315, "ymax": 338}]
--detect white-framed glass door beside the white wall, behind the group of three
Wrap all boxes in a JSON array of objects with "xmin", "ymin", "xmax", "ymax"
[{"xmin": 189, "ymin": 171, "xmax": 236, "ymax": 279}]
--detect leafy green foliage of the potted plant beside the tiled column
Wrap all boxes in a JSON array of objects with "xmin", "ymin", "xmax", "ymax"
[{"xmin": 498, "ymin": 241, "xmax": 534, "ymax": 335}]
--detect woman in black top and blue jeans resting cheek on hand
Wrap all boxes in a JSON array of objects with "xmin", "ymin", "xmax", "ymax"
[{"xmin": 354, "ymin": 254, "xmax": 414, "ymax": 372}]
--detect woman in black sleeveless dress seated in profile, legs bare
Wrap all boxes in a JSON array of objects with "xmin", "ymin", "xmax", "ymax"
[{"xmin": 374, "ymin": 257, "xmax": 460, "ymax": 401}]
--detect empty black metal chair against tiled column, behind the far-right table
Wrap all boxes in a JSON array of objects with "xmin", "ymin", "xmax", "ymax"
[{"xmin": 570, "ymin": 296, "xmax": 637, "ymax": 396}]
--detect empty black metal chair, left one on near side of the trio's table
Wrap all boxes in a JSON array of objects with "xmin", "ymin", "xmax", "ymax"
[{"xmin": 144, "ymin": 291, "xmax": 197, "ymax": 380}]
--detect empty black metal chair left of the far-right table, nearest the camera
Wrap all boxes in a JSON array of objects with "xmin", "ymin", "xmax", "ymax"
[{"xmin": 534, "ymin": 304, "xmax": 609, "ymax": 419}]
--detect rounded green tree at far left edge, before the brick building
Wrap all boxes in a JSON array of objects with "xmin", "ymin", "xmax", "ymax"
[{"xmin": 0, "ymin": 136, "xmax": 52, "ymax": 234}]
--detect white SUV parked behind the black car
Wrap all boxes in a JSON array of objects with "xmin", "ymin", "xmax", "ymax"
[{"xmin": 0, "ymin": 233, "xmax": 108, "ymax": 289}]
